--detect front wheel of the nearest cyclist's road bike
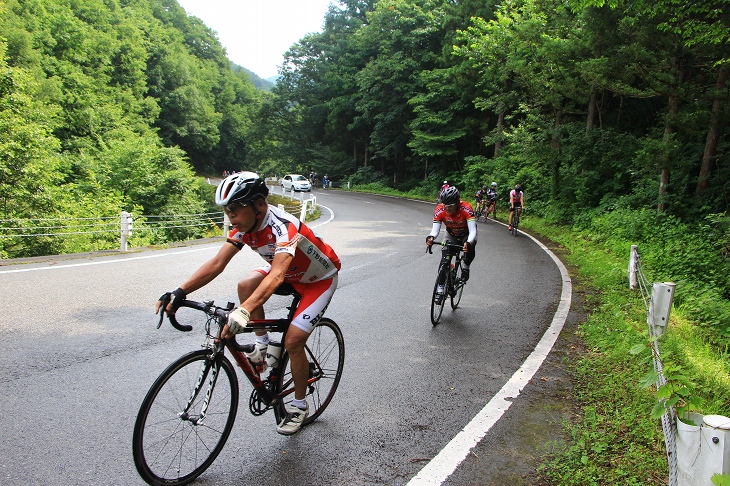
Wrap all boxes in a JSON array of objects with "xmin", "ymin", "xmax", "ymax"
[{"xmin": 132, "ymin": 349, "xmax": 238, "ymax": 485}]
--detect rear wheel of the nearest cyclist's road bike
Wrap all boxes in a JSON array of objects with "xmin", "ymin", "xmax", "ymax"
[{"xmin": 275, "ymin": 317, "xmax": 345, "ymax": 425}]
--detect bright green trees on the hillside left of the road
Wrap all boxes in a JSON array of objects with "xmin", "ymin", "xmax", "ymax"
[{"xmin": 0, "ymin": 0, "xmax": 263, "ymax": 257}]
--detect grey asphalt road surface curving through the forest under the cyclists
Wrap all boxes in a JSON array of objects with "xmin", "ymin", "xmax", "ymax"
[{"xmin": 0, "ymin": 191, "xmax": 565, "ymax": 485}]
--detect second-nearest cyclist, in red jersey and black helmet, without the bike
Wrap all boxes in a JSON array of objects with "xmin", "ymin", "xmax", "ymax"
[{"xmin": 426, "ymin": 186, "xmax": 477, "ymax": 281}]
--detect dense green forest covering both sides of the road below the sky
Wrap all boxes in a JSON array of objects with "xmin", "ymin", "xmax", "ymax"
[{"xmin": 0, "ymin": 0, "xmax": 730, "ymax": 484}]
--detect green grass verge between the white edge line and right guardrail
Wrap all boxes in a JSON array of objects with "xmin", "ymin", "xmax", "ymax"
[{"xmin": 523, "ymin": 217, "xmax": 730, "ymax": 485}]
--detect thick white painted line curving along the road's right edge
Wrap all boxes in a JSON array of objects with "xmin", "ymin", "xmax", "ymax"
[{"xmin": 408, "ymin": 232, "xmax": 573, "ymax": 486}]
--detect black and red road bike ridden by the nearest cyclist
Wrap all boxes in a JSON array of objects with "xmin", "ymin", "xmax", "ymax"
[{"xmin": 132, "ymin": 287, "xmax": 345, "ymax": 485}]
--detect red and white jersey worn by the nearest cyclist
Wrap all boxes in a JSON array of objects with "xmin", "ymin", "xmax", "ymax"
[{"xmin": 228, "ymin": 205, "xmax": 342, "ymax": 284}]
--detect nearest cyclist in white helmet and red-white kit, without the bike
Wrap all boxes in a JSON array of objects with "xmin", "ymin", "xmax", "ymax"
[{"xmin": 155, "ymin": 172, "xmax": 341, "ymax": 435}]
